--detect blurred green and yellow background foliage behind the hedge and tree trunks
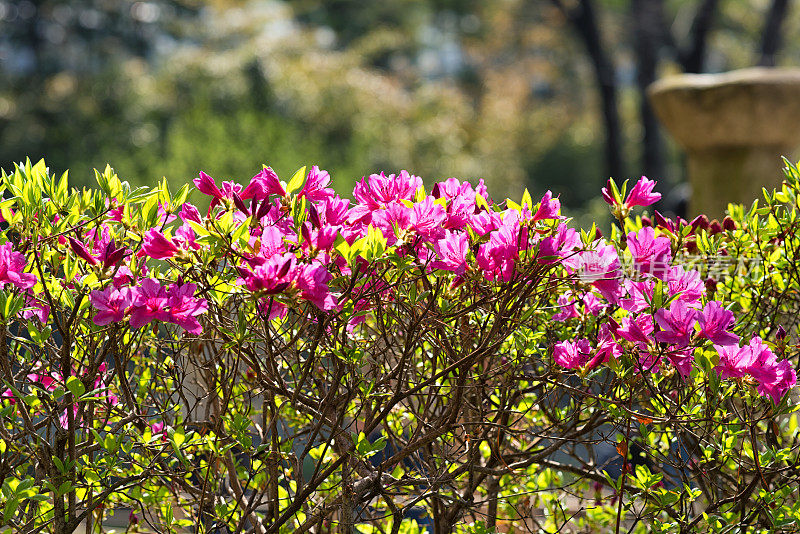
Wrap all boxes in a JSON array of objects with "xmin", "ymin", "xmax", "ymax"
[{"xmin": 0, "ymin": 0, "xmax": 798, "ymax": 214}]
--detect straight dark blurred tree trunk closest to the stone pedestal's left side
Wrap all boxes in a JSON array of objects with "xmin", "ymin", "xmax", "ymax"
[{"xmin": 631, "ymin": 0, "xmax": 665, "ymax": 178}]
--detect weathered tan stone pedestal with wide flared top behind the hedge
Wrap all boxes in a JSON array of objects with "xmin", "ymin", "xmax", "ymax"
[{"xmin": 648, "ymin": 68, "xmax": 800, "ymax": 217}]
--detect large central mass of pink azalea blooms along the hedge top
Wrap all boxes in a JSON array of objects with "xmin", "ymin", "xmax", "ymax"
[{"xmin": 185, "ymin": 166, "xmax": 564, "ymax": 324}]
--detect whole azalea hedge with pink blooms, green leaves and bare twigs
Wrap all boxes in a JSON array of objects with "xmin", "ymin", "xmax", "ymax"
[{"xmin": 0, "ymin": 157, "xmax": 800, "ymax": 534}]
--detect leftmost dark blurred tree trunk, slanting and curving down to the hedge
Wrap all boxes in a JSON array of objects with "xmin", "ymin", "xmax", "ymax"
[{"xmin": 552, "ymin": 0, "xmax": 623, "ymax": 178}]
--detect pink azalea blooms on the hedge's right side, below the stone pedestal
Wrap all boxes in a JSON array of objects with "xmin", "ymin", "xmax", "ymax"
[{"xmin": 553, "ymin": 177, "xmax": 797, "ymax": 403}]
